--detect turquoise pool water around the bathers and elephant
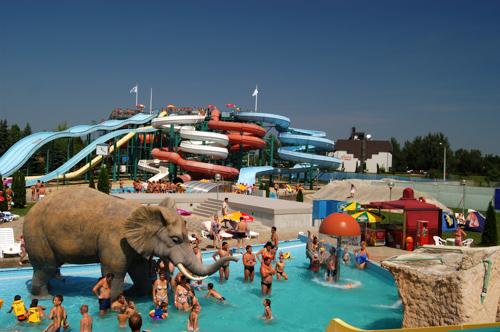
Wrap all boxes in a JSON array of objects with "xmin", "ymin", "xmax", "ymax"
[{"xmin": 0, "ymin": 241, "xmax": 402, "ymax": 332}]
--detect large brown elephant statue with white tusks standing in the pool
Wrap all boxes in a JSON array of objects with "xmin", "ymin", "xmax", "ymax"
[{"xmin": 23, "ymin": 188, "xmax": 238, "ymax": 298}]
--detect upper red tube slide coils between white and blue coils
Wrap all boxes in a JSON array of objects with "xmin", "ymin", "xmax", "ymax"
[{"xmin": 208, "ymin": 107, "xmax": 266, "ymax": 152}]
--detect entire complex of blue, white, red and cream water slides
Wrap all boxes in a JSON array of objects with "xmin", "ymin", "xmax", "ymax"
[{"xmin": 0, "ymin": 105, "xmax": 340, "ymax": 186}]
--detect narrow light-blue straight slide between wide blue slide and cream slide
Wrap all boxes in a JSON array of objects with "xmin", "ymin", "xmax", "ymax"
[{"xmin": 26, "ymin": 126, "xmax": 157, "ymax": 187}]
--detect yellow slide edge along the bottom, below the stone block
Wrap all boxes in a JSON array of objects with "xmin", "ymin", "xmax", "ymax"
[{"xmin": 326, "ymin": 318, "xmax": 500, "ymax": 332}]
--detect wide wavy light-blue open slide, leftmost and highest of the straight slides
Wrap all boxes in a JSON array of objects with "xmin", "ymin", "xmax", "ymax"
[{"xmin": 0, "ymin": 113, "xmax": 156, "ymax": 176}]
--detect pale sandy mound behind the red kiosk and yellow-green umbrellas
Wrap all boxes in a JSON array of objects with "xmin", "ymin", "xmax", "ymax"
[{"xmin": 307, "ymin": 180, "xmax": 448, "ymax": 211}]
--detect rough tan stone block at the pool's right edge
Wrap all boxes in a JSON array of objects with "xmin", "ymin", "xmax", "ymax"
[{"xmin": 382, "ymin": 246, "xmax": 500, "ymax": 328}]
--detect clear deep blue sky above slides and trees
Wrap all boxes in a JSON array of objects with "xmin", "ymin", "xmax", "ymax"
[{"xmin": 0, "ymin": 0, "xmax": 500, "ymax": 154}]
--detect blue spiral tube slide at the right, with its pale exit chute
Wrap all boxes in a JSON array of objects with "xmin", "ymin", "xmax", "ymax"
[{"xmin": 235, "ymin": 112, "xmax": 341, "ymax": 184}]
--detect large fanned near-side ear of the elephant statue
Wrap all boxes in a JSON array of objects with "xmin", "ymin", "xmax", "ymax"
[{"xmin": 124, "ymin": 206, "xmax": 179, "ymax": 258}]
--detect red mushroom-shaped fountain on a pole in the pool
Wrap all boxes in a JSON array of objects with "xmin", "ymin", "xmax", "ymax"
[{"xmin": 319, "ymin": 212, "xmax": 361, "ymax": 281}]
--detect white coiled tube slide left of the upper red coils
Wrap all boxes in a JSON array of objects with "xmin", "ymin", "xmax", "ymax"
[{"xmin": 151, "ymin": 115, "xmax": 229, "ymax": 159}]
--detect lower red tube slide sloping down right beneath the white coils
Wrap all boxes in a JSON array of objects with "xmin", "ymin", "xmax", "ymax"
[{"xmin": 151, "ymin": 149, "xmax": 240, "ymax": 179}]
